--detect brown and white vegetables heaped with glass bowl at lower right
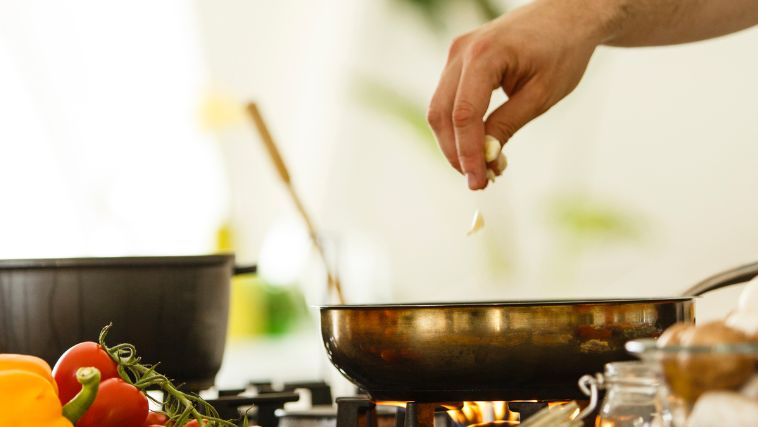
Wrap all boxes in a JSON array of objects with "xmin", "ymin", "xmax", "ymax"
[{"xmin": 656, "ymin": 278, "xmax": 758, "ymax": 427}]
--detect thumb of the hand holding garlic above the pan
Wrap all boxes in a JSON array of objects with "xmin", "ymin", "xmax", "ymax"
[{"xmin": 484, "ymin": 84, "xmax": 550, "ymax": 145}]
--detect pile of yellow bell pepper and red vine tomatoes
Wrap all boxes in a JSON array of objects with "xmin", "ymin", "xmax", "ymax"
[{"xmin": 0, "ymin": 325, "xmax": 236, "ymax": 427}]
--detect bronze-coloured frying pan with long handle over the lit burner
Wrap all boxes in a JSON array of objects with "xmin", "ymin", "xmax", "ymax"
[{"xmin": 320, "ymin": 262, "xmax": 758, "ymax": 402}]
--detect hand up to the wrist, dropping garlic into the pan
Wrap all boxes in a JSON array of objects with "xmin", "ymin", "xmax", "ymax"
[{"xmin": 427, "ymin": 0, "xmax": 603, "ymax": 190}]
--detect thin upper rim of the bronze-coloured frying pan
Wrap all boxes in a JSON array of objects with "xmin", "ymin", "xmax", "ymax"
[{"xmin": 317, "ymin": 296, "xmax": 696, "ymax": 310}]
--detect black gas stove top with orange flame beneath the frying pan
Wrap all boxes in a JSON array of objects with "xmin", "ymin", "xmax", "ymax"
[{"xmin": 200, "ymin": 381, "xmax": 594, "ymax": 427}]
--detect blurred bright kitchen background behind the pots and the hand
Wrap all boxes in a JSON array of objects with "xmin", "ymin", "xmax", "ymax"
[{"xmin": 0, "ymin": 0, "xmax": 758, "ymax": 383}]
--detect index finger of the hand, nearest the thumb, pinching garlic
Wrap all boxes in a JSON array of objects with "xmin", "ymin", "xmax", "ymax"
[{"xmin": 453, "ymin": 64, "xmax": 497, "ymax": 190}]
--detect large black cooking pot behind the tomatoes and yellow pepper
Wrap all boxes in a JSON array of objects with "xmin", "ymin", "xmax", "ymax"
[{"xmin": 0, "ymin": 254, "xmax": 254, "ymax": 390}]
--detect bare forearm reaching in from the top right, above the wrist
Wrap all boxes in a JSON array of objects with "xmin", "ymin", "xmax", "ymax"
[{"xmin": 540, "ymin": 0, "xmax": 758, "ymax": 47}]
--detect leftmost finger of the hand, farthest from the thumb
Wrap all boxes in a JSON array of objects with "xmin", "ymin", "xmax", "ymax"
[{"xmin": 427, "ymin": 61, "xmax": 463, "ymax": 173}]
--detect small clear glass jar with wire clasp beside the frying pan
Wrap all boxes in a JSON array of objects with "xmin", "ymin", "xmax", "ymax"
[{"xmin": 594, "ymin": 361, "xmax": 668, "ymax": 427}]
